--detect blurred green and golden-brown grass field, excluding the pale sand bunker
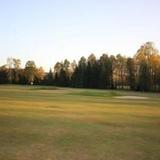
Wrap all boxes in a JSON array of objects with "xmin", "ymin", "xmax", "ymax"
[{"xmin": 0, "ymin": 86, "xmax": 160, "ymax": 160}]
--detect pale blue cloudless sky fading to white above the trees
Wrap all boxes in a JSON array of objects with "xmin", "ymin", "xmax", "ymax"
[{"xmin": 0, "ymin": 0, "xmax": 160, "ymax": 71}]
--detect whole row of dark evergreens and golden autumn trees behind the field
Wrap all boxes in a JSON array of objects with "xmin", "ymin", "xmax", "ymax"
[{"xmin": 0, "ymin": 42, "xmax": 160, "ymax": 91}]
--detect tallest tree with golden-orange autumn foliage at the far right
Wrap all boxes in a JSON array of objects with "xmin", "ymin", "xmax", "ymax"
[{"xmin": 134, "ymin": 42, "xmax": 159, "ymax": 91}]
